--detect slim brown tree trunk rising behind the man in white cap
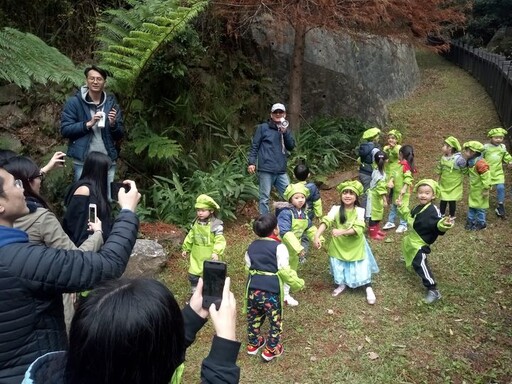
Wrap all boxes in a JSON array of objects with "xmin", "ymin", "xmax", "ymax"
[{"xmin": 287, "ymin": 23, "xmax": 307, "ymax": 132}]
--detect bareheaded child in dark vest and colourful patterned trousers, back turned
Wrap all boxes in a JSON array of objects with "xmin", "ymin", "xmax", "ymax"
[{"xmin": 245, "ymin": 213, "xmax": 304, "ymax": 361}]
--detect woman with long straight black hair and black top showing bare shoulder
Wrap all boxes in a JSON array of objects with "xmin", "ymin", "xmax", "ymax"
[{"xmin": 62, "ymin": 152, "xmax": 112, "ymax": 246}]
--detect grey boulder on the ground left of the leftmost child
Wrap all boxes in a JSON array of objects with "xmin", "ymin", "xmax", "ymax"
[{"xmin": 123, "ymin": 239, "xmax": 167, "ymax": 278}]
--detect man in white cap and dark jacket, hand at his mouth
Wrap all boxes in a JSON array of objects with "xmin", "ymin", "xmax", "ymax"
[{"xmin": 247, "ymin": 103, "xmax": 295, "ymax": 215}]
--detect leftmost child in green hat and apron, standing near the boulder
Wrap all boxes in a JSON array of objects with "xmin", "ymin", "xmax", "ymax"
[{"xmin": 182, "ymin": 195, "xmax": 226, "ymax": 293}]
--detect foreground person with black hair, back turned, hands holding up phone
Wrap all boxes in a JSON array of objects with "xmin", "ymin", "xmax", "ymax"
[{"xmin": 23, "ymin": 278, "xmax": 240, "ymax": 384}]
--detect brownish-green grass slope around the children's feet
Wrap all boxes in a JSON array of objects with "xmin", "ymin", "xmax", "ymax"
[{"xmin": 162, "ymin": 52, "xmax": 512, "ymax": 384}]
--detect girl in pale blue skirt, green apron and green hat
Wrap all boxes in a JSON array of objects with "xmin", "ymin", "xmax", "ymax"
[{"xmin": 314, "ymin": 180, "xmax": 379, "ymax": 304}]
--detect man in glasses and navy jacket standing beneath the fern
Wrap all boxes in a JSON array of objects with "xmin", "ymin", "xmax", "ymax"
[{"xmin": 60, "ymin": 65, "xmax": 124, "ymax": 185}]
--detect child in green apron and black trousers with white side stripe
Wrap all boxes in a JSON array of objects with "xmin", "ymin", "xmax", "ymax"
[{"xmin": 397, "ymin": 179, "xmax": 453, "ymax": 304}]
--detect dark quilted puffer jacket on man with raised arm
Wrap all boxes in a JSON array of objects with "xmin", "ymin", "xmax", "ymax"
[{"xmin": 0, "ymin": 211, "xmax": 139, "ymax": 384}]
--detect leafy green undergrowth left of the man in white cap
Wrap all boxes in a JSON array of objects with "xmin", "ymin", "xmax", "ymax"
[{"xmin": 141, "ymin": 152, "xmax": 258, "ymax": 226}]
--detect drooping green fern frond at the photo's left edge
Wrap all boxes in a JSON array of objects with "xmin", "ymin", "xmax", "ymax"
[{"xmin": 0, "ymin": 28, "xmax": 83, "ymax": 88}]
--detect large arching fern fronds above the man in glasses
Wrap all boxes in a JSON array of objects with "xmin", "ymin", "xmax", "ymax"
[{"xmin": 98, "ymin": 0, "xmax": 207, "ymax": 104}]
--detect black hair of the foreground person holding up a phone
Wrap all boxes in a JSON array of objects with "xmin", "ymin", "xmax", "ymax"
[{"xmin": 66, "ymin": 278, "xmax": 185, "ymax": 384}]
